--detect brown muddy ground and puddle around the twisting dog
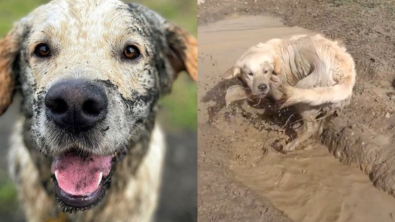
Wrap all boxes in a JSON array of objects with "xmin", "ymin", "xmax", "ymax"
[{"xmin": 198, "ymin": 0, "xmax": 395, "ymax": 222}]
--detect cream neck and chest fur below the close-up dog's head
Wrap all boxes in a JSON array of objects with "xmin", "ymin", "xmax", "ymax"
[{"xmin": 8, "ymin": 119, "xmax": 166, "ymax": 222}]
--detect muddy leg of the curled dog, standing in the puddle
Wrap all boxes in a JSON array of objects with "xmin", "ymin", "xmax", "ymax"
[{"xmin": 283, "ymin": 105, "xmax": 323, "ymax": 152}]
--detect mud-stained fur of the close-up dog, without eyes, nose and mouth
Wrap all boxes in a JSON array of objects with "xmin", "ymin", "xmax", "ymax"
[{"xmin": 0, "ymin": 0, "xmax": 197, "ymax": 222}]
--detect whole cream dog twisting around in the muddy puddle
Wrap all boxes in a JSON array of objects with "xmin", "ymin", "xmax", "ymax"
[{"xmin": 227, "ymin": 35, "xmax": 356, "ymax": 151}]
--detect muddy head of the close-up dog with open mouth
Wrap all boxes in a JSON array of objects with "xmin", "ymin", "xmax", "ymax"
[{"xmin": 0, "ymin": 0, "xmax": 197, "ymax": 210}]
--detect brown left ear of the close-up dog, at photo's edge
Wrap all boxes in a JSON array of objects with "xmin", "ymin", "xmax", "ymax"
[{"xmin": 0, "ymin": 24, "xmax": 23, "ymax": 115}]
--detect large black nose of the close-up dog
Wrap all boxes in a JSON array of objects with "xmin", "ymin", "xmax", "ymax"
[{"xmin": 45, "ymin": 79, "xmax": 107, "ymax": 132}]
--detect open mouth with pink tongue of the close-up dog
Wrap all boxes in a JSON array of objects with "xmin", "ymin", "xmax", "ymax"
[{"xmin": 51, "ymin": 149, "xmax": 124, "ymax": 212}]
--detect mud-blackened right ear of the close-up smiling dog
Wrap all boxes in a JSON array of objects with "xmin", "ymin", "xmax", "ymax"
[{"xmin": 128, "ymin": 3, "xmax": 198, "ymax": 93}]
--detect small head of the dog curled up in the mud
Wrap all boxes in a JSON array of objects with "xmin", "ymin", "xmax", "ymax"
[{"xmin": 226, "ymin": 43, "xmax": 281, "ymax": 97}]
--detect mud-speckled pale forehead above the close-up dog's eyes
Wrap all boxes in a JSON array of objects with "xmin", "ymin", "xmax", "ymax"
[{"xmin": 30, "ymin": 0, "xmax": 155, "ymax": 44}]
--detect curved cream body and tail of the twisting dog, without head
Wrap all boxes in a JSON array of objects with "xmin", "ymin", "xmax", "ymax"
[{"xmin": 282, "ymin": 35, "xmax": 356, "ymax": 106}]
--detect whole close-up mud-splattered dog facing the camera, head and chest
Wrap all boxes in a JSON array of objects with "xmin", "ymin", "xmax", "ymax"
[{"xmin": 0, "ymin": 0, "xmax": 197, "ymax": 222}]
